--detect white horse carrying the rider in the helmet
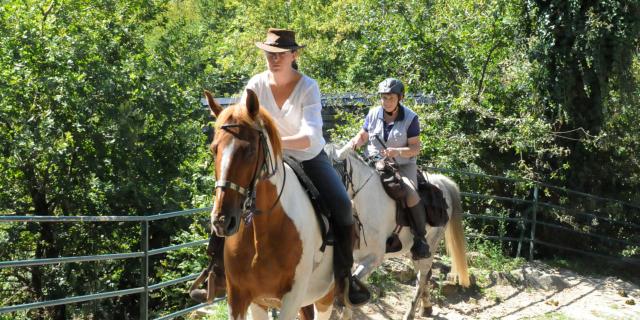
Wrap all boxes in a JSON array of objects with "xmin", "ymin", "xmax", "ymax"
[{"xmin": 325, "ymin": 145, "xmax": 470, "ymax": 319}]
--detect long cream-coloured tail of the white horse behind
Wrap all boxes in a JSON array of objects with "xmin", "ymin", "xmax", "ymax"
[{"xmin": 442, "ymin": 176, "xmax": 471, "ymax": 287}]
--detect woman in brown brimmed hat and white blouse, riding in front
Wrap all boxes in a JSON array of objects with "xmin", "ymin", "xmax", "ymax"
[{"xmin": 214, "ymin": 28, "xmax": 371, "ymax": 306}]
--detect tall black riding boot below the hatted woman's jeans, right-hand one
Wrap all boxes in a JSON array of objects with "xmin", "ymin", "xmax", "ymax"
[{"xmin": 333, "ymin": 226, "xmax": 371, "ymax": 307}]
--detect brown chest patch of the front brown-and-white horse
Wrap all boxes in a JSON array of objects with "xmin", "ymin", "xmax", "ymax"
[{"xmin": 225, "ymin": 181, "xmax": 302, "ymax": 317}]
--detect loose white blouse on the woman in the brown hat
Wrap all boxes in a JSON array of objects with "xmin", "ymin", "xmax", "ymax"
[{"xmin": 240, "ymin": 71, "xmax": 325, "ymax": 161}]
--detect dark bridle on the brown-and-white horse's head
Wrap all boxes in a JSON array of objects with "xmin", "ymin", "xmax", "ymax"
[{"xmin": 215, "ymin": 124, "xmax": 287, "ymax": 219}]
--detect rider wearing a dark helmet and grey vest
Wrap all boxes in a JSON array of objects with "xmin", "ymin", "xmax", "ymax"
[{"xmin": 349, "ymin": 78, "xmax": 431, "ymax": 260}]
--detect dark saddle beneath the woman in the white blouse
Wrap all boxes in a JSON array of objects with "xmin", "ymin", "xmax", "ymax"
[{"xmin": 284, "ymin": 157, "xmax": 333, "ymax": 252}]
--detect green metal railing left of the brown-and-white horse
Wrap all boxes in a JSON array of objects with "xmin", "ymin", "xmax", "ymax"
[{"xmin": 0, "ymin": 207, "xmax": 222, "ymax": 320}]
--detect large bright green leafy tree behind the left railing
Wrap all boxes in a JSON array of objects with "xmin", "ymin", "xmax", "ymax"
[{"xmin": 0, "ymin": 0, "xmax": 210, "ymax": 319}]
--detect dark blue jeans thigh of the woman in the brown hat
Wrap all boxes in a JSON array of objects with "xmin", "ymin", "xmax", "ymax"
[{"xmin": 302, "ymin": 150, "xmax": 353, "ymax": 227}]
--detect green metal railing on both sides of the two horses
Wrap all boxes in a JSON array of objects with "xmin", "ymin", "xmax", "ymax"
[{"xmin": 0, "ymin": 168, "xmax": 640, "ymax": 320}]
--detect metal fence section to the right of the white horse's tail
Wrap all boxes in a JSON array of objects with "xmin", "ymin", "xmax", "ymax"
[{"xmin": 426, "ymin": 167, "xmax": 640, "ymax": 265}]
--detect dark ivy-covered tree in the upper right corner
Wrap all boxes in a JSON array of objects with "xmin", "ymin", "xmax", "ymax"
[{"xmin": 523, "ymin": 0, "xmax": 640, "ymax": 194}]
